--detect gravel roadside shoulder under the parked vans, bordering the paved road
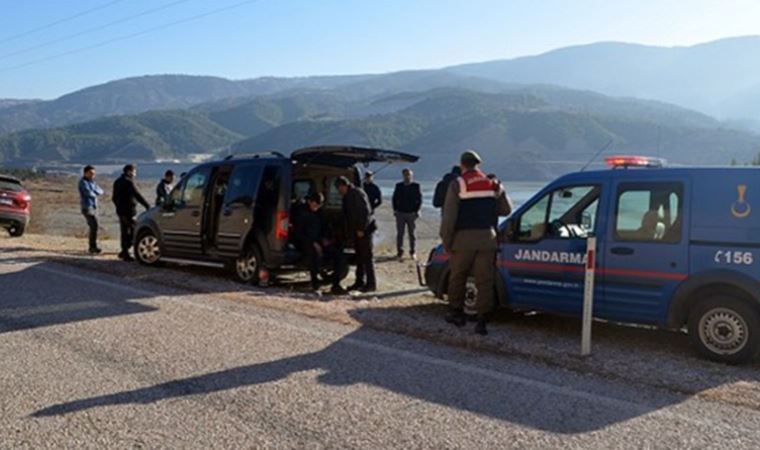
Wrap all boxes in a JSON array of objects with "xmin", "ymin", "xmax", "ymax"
[{"xmin": 0, "ymin": 235, "xmax": 760, "ymax": 408}]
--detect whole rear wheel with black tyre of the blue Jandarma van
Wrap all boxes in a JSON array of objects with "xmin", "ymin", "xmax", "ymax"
[{"xmin": 688, "ymin": 295, "xmax": 760, "ymax": 364}]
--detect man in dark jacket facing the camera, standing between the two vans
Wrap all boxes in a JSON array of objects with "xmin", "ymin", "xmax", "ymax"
[{"xmin": 393, "ymin": 169, "xmax": 422, "ymax": 259}]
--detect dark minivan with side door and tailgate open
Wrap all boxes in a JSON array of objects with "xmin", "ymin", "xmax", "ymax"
[{"xmin": 134, "ymin": 146, "xmax": 418, "ymax": 283}]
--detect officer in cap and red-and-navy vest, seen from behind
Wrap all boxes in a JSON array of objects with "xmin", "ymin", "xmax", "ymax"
[{"xmin": 440, "ymin": 150, "xmax": 512, "ymax": 335}]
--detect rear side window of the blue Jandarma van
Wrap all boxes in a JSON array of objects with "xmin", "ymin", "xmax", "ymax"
[{"xmin": 614, "ymin": 183, "xmax": 683, "ymax": 243}]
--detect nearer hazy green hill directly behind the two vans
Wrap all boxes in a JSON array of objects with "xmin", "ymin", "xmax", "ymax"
[{"xmin": 232, "ymin": 88, "xmax": 760, "ymax": 179}]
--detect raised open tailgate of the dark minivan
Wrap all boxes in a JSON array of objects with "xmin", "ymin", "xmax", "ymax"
[{"xmin": 290, "ymin": 145, "xmax": 420, "ymax": 167}]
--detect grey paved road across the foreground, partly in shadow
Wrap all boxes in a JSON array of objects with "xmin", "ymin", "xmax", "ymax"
[{"xmin": 0, "ymin": 251, "xmax": 760, "ymax": 449}]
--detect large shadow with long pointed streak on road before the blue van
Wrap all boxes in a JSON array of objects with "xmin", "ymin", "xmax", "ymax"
[{"xmin": 33, "ymin": 308, "xmax": 757, "ymax": 434}]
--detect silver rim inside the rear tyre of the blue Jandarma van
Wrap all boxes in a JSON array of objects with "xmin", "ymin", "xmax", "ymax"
[{"xmin": 699, "ymin": 308, "xmax": 748, "ymax": 355}]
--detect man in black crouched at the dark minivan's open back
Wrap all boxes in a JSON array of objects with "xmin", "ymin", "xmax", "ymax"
[{"xmin": 293, "ymin": 193, "xmax": 346, "ymax": 295}]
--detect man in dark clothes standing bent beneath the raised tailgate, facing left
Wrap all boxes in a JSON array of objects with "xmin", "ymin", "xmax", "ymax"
[{"xmin": 335, "ymin": 177, "xmax": 377, "ymax": 292}]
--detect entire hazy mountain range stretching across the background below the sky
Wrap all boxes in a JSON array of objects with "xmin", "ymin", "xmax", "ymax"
[{"xmin": 0, "ymin": 37, "xmax": 760, "ymax": 178}]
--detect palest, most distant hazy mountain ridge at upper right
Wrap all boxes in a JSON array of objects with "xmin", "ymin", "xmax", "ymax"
[{"xmin": 445, "ymin": 36, "xmax": 760, "ymax": 118}]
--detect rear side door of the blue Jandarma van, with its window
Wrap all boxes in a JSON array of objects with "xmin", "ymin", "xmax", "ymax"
[{"xmin": 594, "ymin": 176, "xmax": 690, "ymax": 323}]
